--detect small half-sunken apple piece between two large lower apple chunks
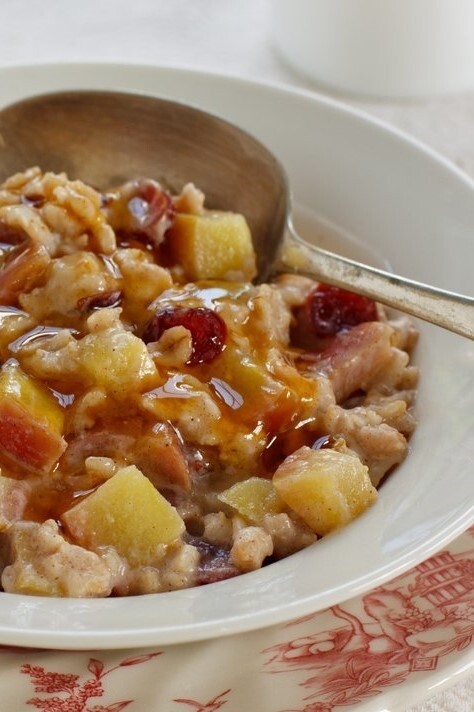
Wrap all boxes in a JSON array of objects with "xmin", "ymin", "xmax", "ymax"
[{"xmin": 219, "ymin": 477, "xmax": 284, "ymax": 524}]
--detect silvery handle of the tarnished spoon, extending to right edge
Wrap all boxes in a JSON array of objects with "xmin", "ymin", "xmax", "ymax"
[{"xmin": 276, "ymin": 224, "xmax": 474, "ymax": 339}]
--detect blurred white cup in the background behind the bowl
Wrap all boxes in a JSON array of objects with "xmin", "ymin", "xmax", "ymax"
[{"xmin": 271, "ymin": 0, "xmax": 474, "ymax": 98}]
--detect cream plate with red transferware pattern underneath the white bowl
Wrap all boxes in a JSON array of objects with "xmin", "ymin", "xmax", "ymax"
[{"xmin": 0, "ymin": 527, "xmax": 474, "ymax": 712}]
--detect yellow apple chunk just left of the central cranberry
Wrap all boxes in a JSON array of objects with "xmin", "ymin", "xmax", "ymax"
[{"xmin": 79, "ymin": 327, "xmax": 156, "ymax": 397}]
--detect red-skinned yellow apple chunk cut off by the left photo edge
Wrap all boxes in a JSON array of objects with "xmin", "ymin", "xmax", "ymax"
[{"xmin": 0, "ymin": 363, "xmax": 66, "ymax": 474}]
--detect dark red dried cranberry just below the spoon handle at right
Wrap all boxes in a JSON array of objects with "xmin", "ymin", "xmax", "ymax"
[{"xmin": 308, "ymin": 284, "xmax": 377, "ymax": 336}]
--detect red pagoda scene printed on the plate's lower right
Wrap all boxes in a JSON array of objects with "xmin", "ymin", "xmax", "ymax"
[{"xmin": 263, "ymin": 528, "xmax": 474, "ymax": 712}]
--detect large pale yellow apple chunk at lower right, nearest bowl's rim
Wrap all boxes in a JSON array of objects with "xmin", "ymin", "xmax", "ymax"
[{"xmin": 273, "ymin": 447, "xmax": 377, "ymax": 536}]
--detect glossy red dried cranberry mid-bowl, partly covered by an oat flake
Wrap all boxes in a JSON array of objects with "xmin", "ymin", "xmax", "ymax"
[{"xmin": 142, "ymin": 307, "xmax": 227, "ymax": 366}]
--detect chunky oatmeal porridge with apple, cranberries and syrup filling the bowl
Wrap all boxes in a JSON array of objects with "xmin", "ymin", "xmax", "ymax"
[{"xmin": 0, "ymin": 168, "xmax": 417, "ymax": 597}]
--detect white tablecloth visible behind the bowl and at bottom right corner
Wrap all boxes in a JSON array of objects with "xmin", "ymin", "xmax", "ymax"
[{"xmin": 0, "ymin": 0, "xmax": 474, "ymax": 712}]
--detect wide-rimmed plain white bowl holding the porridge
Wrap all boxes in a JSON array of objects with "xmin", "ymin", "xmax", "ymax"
[{"xmin": 0, "ymin": 64, "xmax": 474, "ymax": 650}]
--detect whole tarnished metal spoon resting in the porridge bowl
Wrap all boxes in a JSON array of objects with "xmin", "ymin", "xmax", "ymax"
[{"xmin": 0, "ymin": 91, "xmax": 474, "ymax": 339}]
